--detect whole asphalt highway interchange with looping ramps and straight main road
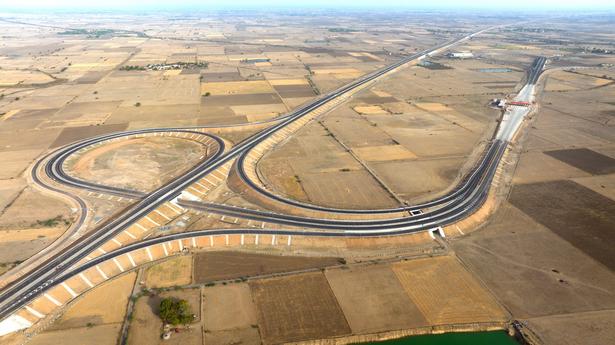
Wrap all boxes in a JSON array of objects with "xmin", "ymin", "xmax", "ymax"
[{"xmin": 0, "ymin": 28, "xmax": 546, "ymax": 328}]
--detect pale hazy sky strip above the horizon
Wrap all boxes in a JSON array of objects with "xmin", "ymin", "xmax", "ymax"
[{"xmin": 0, "ymin": 0, "xmax": 615, "ymax": 10}]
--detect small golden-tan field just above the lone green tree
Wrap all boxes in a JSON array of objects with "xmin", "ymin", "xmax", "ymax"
[{"xmin": 143, "ymin": 256, "xmax": 192, "ymax": 288}]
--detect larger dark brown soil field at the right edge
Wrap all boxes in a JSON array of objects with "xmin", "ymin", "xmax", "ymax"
[{"xmin": 510, "ymin": 181, "xmax": 615, "ymax": 270}]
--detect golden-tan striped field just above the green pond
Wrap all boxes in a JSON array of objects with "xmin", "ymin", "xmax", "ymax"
[{"xmin": 393, "ymin": 256, "xmax": 506, "ymax": 325}]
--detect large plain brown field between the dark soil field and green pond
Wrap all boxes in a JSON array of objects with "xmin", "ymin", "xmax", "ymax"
[{"xmin": 452, "ymin": 200, "xmax": 615, "ymax": 318}]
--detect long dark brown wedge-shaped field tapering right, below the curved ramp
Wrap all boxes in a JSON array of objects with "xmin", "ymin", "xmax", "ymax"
[{"xmin": 194, "ymin": 252, "xmax": 339, "ymax": 284}]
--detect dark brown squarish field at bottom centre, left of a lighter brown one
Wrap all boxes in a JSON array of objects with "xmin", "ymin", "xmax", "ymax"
[{"xmin": 250, "ymin": 273, "xmax": 350, "ymax": 344}]
